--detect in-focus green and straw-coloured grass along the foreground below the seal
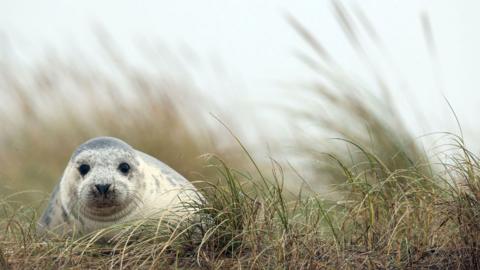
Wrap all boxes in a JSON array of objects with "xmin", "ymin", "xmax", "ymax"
[{"xmin": 0, "ymin": 139, "xmax": 480, "ymax": 269}]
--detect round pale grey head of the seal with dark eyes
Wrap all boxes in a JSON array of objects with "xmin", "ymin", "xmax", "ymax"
[{"xmin": 61, "ymin": 137, "xmax": 143, "ymax": 222}]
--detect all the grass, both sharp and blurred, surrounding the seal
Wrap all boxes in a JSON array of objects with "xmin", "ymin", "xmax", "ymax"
[{"xmin": 0, "ymin": 5, "xmax": 480, "ymax": 269}]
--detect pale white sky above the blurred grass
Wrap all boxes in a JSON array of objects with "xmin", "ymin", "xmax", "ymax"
[{"xmin": 0, "ymin": 0, "xmax": 480, "ymax": 149}]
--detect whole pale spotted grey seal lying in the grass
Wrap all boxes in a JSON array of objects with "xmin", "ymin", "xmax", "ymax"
[{"xmin": 38, "ymin": 137, "xmax": 202, "ymax": 233}]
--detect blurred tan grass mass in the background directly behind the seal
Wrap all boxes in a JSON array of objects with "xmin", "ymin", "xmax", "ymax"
[{"xmin": 0, "ymin": 37, "xmax": 246, "ymax": 205}]
